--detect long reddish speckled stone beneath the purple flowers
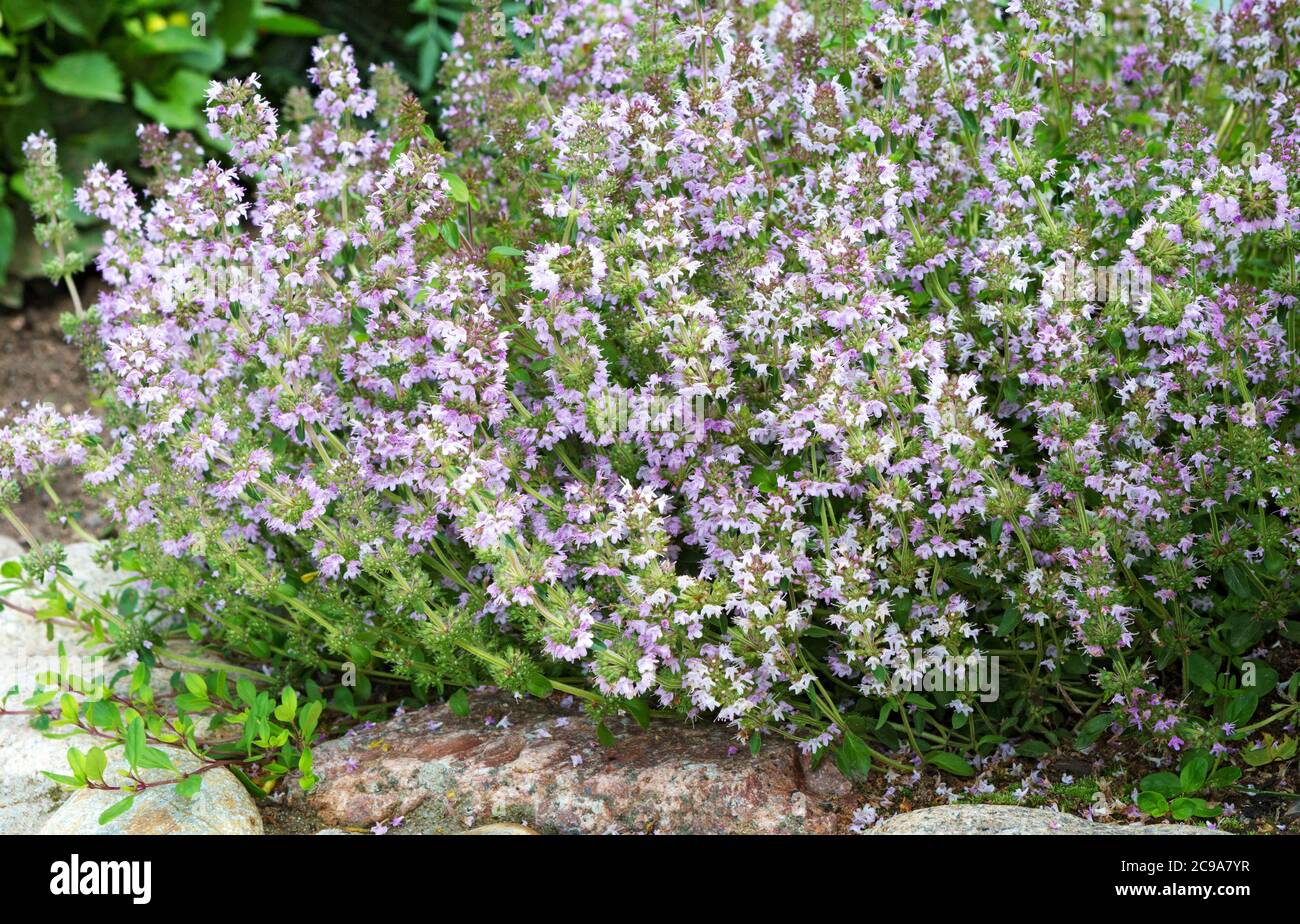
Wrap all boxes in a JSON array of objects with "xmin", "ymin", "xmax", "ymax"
[{"xmin": 286, "ymin": 694, "xmax": 853, "ymax": 834}]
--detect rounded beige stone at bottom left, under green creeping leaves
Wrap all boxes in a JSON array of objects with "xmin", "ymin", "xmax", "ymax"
[{"xmin": 39, "ymin": 750, "xmax": 261, "ymax": 834}]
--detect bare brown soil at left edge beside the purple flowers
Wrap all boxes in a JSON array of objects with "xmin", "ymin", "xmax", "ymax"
[{"xmin": 0, "ymin": 282, "xmax": 99, "ymax": 542}]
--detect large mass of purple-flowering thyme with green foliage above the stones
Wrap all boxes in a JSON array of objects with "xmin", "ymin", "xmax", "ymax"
[{"xmin": 0, "ymin": 0, "xmax": 1300, "ymax": 819}]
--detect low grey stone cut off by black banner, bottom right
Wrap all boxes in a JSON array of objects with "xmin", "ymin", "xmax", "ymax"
[{"xmin": 871, "ymin": 806, "xmax": 1227, "ymax": 834}]
